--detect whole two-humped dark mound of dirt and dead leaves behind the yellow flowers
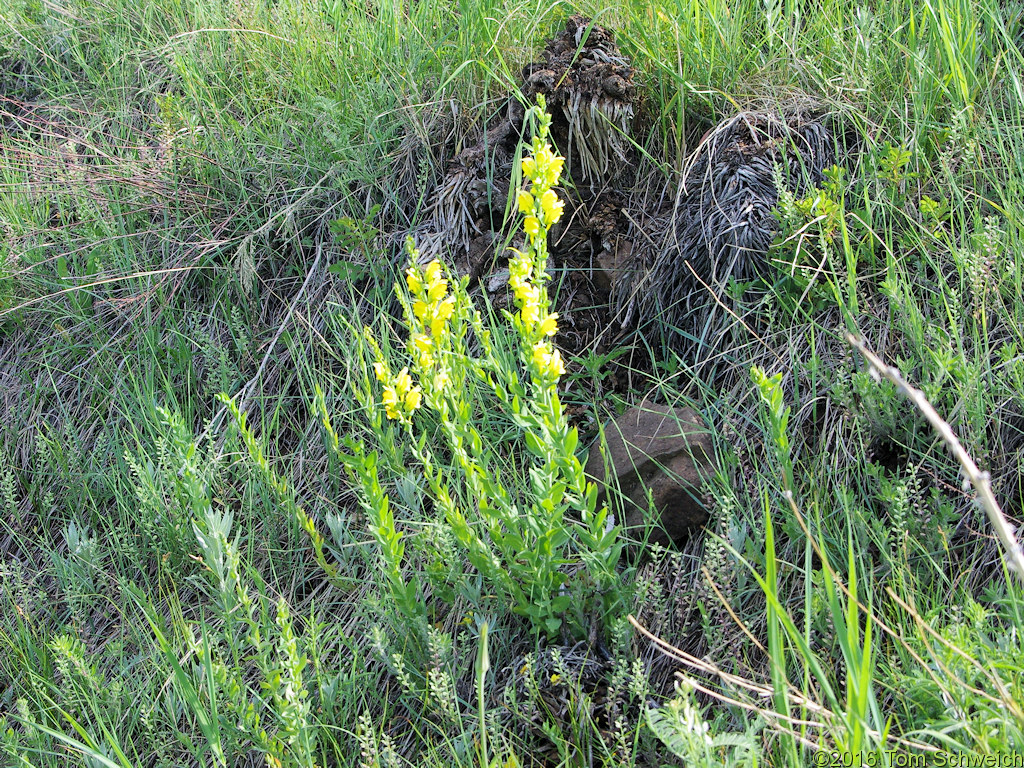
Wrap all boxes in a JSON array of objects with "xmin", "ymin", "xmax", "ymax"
[{"xmin": 403, "ymin": 15, "xmax": 836, "ymax": 355}]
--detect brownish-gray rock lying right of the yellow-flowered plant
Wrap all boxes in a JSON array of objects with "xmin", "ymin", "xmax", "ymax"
[{"xmin": 586, "ymin": 404, "xmax": 716, "ymax": 546}]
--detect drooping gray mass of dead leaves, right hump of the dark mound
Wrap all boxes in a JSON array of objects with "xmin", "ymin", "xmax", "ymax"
[{"xmin": 614, "ymin": 112, "xmax": 837, "ymax": 337}]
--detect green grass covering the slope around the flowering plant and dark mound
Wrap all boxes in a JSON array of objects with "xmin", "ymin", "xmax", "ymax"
[{"xmin": 0, "ymin": 0, "xmax": 1024, "ymax": 768}]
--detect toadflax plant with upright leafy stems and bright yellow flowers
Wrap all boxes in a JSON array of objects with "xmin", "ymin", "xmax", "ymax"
[{"xmin": 335, "ymin": 100, "xmax": 622, "ymax": 637}]
